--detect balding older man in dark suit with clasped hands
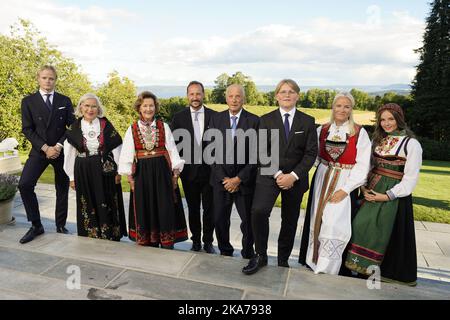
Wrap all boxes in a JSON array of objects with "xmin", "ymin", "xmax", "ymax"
[{"xmin": 209, "ymin": 84, "xmax": 259, "ymax": 259}]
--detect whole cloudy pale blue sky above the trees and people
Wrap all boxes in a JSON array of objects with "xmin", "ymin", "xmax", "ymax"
[{"xmin": 0, "ymin": 0, "xmax": 429, "ymax": 85}]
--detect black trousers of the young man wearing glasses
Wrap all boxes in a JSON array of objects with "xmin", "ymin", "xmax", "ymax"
[{"xmin": 251, "ymin": 182, "xmax": 303, "ymax": 261}]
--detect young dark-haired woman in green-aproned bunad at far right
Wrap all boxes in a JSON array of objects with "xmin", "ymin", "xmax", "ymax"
[{"xmin": 345, "ymin": 103, "xmax": 422, "ymax": 285}]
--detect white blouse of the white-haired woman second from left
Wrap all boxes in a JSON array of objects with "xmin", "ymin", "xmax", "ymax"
[{"xmin": 64, "ymin": 118, "xmax": 122, "ymax": 181}]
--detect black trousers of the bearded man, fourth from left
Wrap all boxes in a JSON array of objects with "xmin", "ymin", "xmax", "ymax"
[{"xmin": 181, "ymin": 179, "xmax": 214, "ymax": 243}]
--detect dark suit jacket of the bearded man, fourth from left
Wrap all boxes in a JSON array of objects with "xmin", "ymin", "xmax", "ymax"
[{"xmin": 170, "ymin": 107, "xmax": 217, "ymax": 181}]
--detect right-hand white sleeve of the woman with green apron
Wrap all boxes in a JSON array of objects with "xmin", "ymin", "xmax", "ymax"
[{"xmin": 386, "ymin": 139, "xmax": 422, "ymax": 199}]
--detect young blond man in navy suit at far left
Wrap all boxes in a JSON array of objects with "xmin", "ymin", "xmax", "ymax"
[{"xmin": 19, "ymin": 66, "xmax": 75, "ymax": 243}]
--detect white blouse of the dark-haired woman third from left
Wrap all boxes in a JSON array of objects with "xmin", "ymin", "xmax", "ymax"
[{"xmin": 118, "ymin": 121, "xmax": 185, "ymax": 175}]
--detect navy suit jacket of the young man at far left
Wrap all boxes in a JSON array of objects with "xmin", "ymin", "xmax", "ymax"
[{"xmin": 21, "ymin": 91, "xmax": 75, "ymax": 158}]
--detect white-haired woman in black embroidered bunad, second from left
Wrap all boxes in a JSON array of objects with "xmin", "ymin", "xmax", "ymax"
[{"xmin": 64, "ymin": 93, "xmax": 127, "ymax": 241}]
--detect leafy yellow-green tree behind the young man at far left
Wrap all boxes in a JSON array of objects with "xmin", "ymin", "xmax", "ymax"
[{"xmin": 0, "ymin": 19, "xmax": 92, "ymax": 149}]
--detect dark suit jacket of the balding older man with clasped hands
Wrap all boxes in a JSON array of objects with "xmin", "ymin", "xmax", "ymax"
[{"xmin": 209, "ymin": 109, "xmax": 259, "ymax": 194}]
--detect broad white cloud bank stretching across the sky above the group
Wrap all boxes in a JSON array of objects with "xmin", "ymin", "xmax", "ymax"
[{"xmin": 0, "ymin": 0, "xmax": 425, "ymax": 85}]
